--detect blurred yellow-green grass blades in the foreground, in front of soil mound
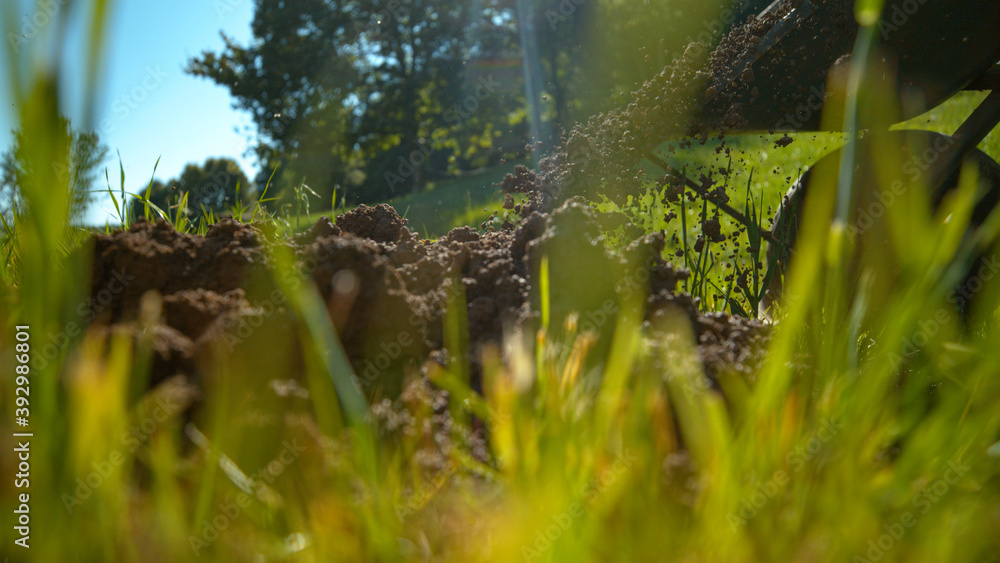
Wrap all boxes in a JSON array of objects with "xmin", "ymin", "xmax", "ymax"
[{"xmin": 0, "ymin": 184, "xmax": 1000, "ymax": 561}]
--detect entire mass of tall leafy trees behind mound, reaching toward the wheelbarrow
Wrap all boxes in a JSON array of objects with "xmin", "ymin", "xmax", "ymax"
[{"xmin": 186, "ymin": 0, "xmax": 715, "ymax": 208}]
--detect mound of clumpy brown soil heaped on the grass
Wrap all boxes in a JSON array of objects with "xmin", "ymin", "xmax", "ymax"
[{"xmin": 92, "ymin": 203, "xmax": 766, "ymax": 399}]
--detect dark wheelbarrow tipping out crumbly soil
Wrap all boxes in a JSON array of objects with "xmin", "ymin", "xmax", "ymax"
[{"xmin": 652, "ymin": 0, "xmax": 1000, "ymax": 316}]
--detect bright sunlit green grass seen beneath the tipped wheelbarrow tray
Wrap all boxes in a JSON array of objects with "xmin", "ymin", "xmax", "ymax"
[{"xmin": 588, "ymin": 92, "xmax": 1000, "ymax": 316}]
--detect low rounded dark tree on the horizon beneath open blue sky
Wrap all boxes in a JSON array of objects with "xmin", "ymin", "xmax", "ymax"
[{"xmin": 129, "ymin": 158, "xmax": 254, "ymax": 223}]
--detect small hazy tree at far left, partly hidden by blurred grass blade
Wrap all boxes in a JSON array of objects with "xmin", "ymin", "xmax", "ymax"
[{"xmin": 0, "ymin": 118, "xmax": 109, "ymax": 220}]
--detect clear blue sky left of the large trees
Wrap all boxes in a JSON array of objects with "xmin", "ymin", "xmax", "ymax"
[{"xmin": 0, "ymin": 0, "xmax": 256, "ymax": 224}]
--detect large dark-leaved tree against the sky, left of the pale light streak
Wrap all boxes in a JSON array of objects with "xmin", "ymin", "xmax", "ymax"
[{"xmin": 187, "ymin": 0, "xmax": 521, "ymax": 205}]
